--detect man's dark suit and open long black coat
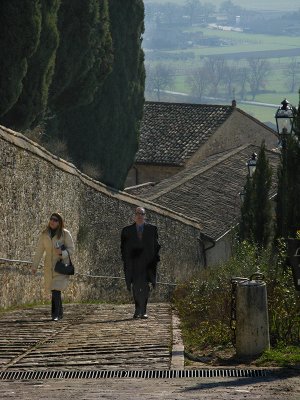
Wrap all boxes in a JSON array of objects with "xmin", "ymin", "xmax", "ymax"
[{"xmin": 121, "ymin": 223, "xmax": 160, "ymax": 315}]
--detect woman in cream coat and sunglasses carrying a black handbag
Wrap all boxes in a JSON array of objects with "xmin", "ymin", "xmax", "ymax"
[{"xmin": 32, "ymin": 212, "xmax": 74, "ymax": 321}]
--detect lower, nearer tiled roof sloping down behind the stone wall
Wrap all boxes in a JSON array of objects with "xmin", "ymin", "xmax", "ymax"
[{"xmin": 130, "ymin": 145, "xmax": 279, "ymax": 240}]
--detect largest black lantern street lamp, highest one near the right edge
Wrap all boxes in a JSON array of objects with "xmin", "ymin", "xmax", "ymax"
[{"xmin": 275, "ymin": 99, "xmax": 295, "ymax": 149}]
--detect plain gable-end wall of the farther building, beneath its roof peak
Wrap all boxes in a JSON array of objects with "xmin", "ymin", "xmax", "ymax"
[{"xmin": 186, "ymin": 109, "xmax": 278, "ymax": 167}]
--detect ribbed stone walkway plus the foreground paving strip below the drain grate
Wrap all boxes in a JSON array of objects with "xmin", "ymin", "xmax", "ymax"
[{"xmin": 0, "ymin": 304, "xmax": 300, "ymax": 400}]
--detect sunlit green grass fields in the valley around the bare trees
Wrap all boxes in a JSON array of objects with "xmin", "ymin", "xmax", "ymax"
[{"xmin": 146, "ymin": 27, "xmax": 300, "ymax": 122}]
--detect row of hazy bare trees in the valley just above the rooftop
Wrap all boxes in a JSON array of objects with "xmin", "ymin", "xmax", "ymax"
[{"xmin": 146, "ymin": 56, "xmax": 300, "ymax": 102}]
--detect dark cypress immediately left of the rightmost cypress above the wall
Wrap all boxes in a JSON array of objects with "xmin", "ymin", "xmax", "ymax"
[{"xmin": 49, "ymin": 0, "xmax": 112, "ymax": 115}]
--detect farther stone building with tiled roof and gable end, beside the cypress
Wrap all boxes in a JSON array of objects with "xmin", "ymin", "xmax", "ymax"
[{"xmin": 125, "ymin": 102, "xmax": 278, "ymax": 187}]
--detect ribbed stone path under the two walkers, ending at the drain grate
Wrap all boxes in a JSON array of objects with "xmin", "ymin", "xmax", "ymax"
[{"xmin": 0, "ymin": 304, "xmax": 172, "ymax": 371}]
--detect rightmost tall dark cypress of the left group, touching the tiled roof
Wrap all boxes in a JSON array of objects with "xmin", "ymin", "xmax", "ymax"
[{"xmin": 50, "ymin": 0, "xmax": 145, "ymax": 188}]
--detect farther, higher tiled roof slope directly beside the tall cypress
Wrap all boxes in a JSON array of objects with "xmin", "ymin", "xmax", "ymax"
[{"xmin": 136, "ymin": 102, "xmax": 233, "ymax": 165}]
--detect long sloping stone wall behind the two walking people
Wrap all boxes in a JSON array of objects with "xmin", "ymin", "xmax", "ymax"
[{"xmin": 0, "ymin": 127, "xmax": 203, "ymax": 307}]
